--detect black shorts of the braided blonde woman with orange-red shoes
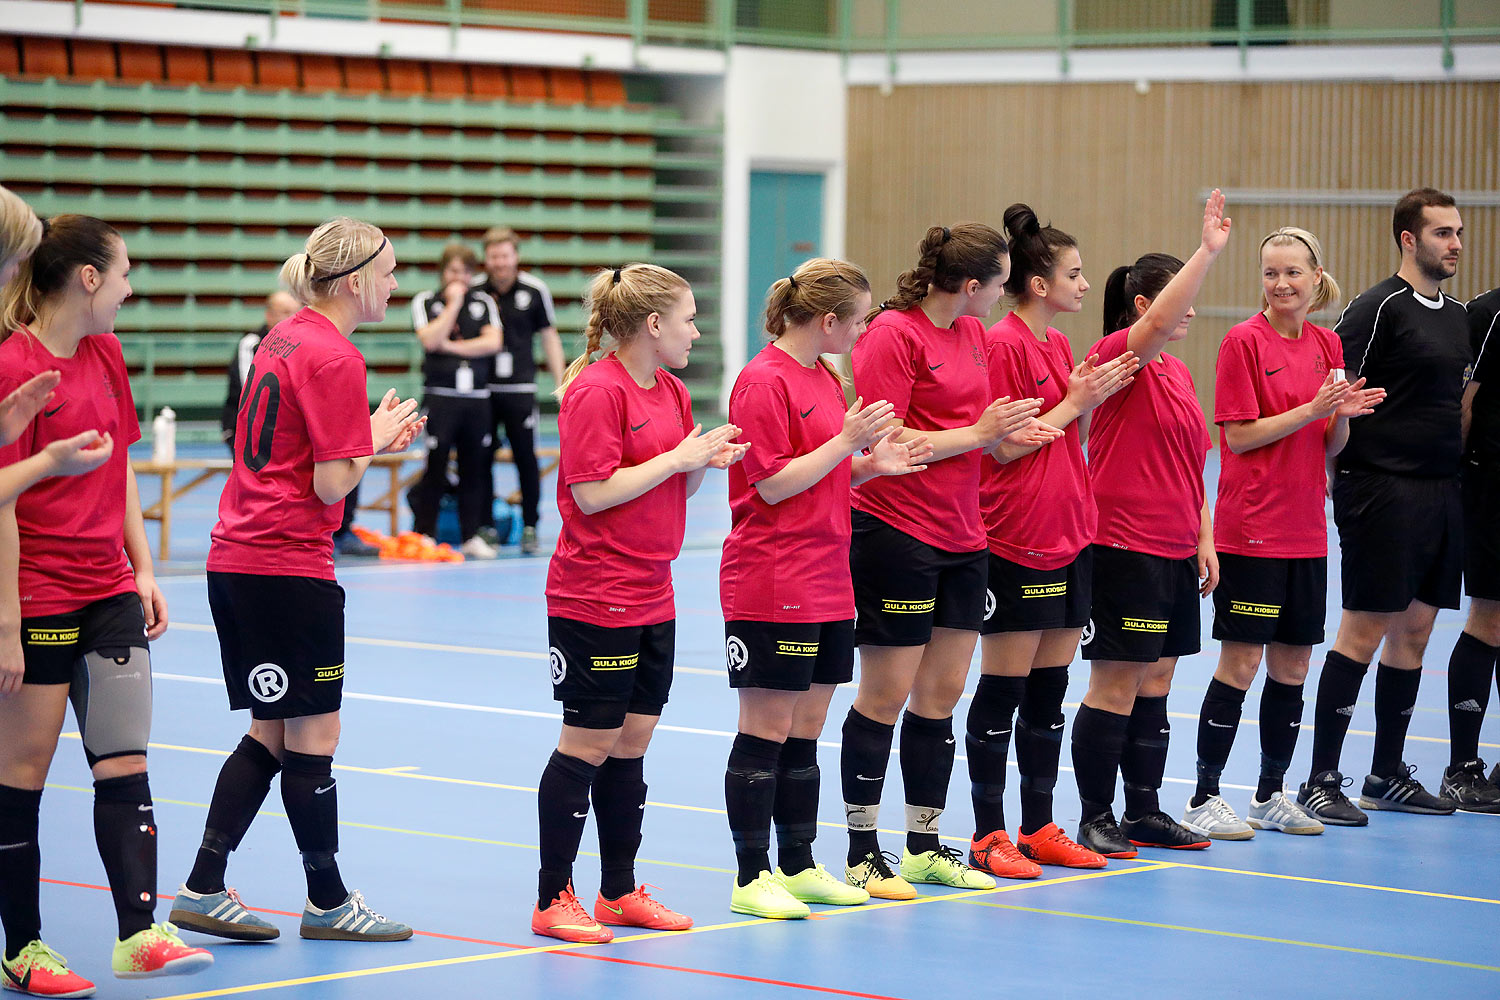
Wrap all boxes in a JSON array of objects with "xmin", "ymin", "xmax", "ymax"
[{"xmin": 548, "ymin": 615, "xmax": 677, "ymax": 729}]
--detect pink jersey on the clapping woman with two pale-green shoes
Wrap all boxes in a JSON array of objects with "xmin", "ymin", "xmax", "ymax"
[{"xmin": 719, "ymin": 345, "xmax": 854, "ymax": 622}]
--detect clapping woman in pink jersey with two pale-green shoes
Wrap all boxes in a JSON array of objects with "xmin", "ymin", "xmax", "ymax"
[{"xmin": 720, "ymin": 258, "xmax": 929, "ymax": 919}]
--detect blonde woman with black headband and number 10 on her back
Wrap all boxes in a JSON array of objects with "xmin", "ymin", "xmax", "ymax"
[{"xmin": 173, "ymin": 217, "xmax": 423, "ymax": 942}]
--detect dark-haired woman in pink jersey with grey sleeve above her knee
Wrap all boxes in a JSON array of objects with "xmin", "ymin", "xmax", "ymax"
[{"xmin": 0, "ymin": 215, "xmax": 213, "ymax": 997}]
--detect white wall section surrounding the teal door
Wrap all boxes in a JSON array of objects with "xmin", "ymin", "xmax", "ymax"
[{"xmin": 720, "ymin": 46, "xmax": 848, "ymax": 405}]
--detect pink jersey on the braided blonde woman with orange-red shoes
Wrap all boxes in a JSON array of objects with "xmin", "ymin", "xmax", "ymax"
[{"xmin": 548, "ymin": 354, "xmax": 693, "ymax": 628}]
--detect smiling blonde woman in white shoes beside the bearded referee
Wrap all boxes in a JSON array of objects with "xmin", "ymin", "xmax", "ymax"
[{"xmin": 1182, "ymin": 226, "xmax": 1386, "ymax": 840}]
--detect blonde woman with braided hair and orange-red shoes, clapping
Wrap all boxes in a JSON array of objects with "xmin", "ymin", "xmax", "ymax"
[{"xmin": 543, "ymin": 264, "xmax": 749, "ymax": 943}]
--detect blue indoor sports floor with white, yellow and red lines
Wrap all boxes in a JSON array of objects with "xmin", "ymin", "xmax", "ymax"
[{"xmin": 26, "ymin": 446, "xmax": 1500, "ymax": 1000}]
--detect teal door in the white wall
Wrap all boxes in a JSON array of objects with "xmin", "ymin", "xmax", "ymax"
[{"xmin": 746, "ymin": 169, "xmax": 824, "ymax": 360}]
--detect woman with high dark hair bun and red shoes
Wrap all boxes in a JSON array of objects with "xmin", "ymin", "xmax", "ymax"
[{"xmin": 965, "ymin": 204, "xmax": 1136, "ymax": 879}]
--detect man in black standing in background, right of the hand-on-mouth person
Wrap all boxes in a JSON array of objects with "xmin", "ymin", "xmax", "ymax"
[{"xmin": 479, "ymin": 226, "xmax": 567, "ymax": 555}]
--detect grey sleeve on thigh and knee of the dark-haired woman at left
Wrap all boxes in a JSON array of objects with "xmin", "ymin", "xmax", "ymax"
[{"xmin": 69, "ymin": 646, "xmax": 152, "ymax": 768}]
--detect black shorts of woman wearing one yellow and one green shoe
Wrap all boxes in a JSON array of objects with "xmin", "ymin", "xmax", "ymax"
[{"xmin": 849, "ymin": 510, "xmax": 990, "ymax": 646}]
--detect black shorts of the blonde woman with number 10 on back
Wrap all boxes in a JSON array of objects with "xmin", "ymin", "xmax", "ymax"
[{"xmin": 209, "ymin": 573, "xmax": 344, "ymax": 720}]
